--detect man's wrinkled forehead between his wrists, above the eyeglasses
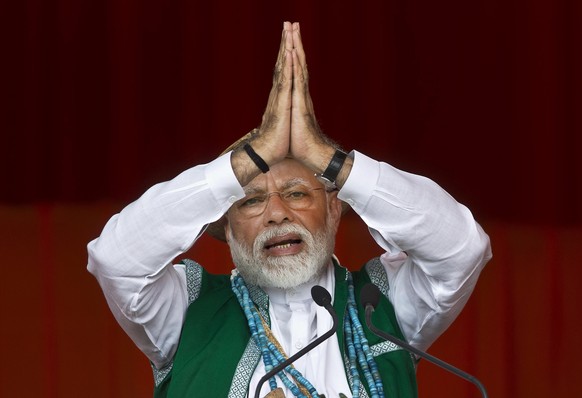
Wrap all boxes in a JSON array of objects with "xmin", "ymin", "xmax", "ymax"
[{"xmin": 244, "ymin": 158, "xmax": 322, "ymax": 191}]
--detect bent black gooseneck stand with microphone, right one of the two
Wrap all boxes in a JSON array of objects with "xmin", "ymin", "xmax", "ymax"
[{"xmin": 362, "ymin": 283, "xmax": 488, "ymax": 398}]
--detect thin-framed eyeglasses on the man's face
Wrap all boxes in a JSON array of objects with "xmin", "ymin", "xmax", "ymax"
[{"xmin": 235, "ymin": 186, "xmax": 325, "ymax": 217}]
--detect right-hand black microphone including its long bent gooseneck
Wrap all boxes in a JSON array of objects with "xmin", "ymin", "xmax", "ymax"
[{"xmin": 360, "ymin": 283, "xmax": 487, "ymax": 398}]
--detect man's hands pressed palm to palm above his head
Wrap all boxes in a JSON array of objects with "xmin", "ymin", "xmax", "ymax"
[{"xmin": 231, "ymin": 22, "xmax": 346, "ymax": 185}]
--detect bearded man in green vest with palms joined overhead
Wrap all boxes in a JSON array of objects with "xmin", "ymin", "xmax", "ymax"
[{"xmin": 88, "ymin": 22, "xmax": 491, "ymax": 398}]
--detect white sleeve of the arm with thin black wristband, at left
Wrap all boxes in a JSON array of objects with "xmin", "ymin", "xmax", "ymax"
[{"xmin": 87, "ymin": 153, "xmax": 244, "ymax": 368}]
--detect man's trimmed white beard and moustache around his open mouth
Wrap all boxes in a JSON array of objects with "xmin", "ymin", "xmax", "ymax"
[{"xmin": 229, "ymin": 219, "xmax": 335, "ymax": 289}]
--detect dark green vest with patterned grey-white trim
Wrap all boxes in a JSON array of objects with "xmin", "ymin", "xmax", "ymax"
[{"xmin": 154, "ymin": 258, "xmax": 417, "ymax": 398}]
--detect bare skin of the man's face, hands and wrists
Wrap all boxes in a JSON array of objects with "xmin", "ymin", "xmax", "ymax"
[{"xmin": 224, "ymin": 22, "xmax": 351, "ymax": 264}]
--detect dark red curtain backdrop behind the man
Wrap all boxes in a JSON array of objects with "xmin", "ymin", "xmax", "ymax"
[{"xmin": 0, "ymin": 0, "xmax": 582, "ymax": 397}]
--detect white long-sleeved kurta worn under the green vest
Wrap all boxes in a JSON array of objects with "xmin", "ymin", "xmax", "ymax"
[{"xmin": 88, "ymin": 151, "xmax": 491, "ymax": 396}]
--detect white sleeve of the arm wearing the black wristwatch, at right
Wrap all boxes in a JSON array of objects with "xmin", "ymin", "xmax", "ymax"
[{"xmin": 338, "ymin": 151, "xmax": 491, "ymax": 350}]
